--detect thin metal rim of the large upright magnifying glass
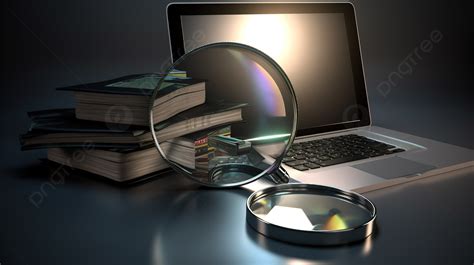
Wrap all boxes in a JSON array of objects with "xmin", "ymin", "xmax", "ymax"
[{"xmin": 148, "ymin": 42, "xmax": 298, "ymax": 188}]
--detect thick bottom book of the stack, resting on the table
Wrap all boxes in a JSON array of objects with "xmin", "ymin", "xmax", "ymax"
[{"xmin": 48, "ymin": 126, "xmax": 230, "ymax": 182}]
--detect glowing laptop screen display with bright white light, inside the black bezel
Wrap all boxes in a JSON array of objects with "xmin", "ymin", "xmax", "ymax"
[{"xmin": 170, "ymin": 3, "xmax": 365, "ymax": 135}]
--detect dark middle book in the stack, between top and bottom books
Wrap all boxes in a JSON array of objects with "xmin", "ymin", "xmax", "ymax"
[{"xmin": 20, "ymin": 103, "xmax": 245, "ymax": 150}]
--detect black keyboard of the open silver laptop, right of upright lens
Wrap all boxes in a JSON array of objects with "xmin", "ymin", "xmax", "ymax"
[{"xmin": 283, "ymin": 134, "xmax": 405, "ymax": 171}]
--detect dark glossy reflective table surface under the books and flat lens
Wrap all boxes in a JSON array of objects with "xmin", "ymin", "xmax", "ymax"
[{"xmin": 0, "ymin": 147, "xmax": 474, "ymax": 265}]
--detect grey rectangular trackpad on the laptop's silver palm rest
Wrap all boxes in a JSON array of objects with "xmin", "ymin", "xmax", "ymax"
[{"xmin": 352, "ymin": 156, "xmax": 436, "ymax": 179}]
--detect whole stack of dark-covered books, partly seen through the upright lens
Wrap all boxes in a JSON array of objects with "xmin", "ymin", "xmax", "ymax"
[{"xmin": 20, "ymin": 71, "xmax": 245, "ymax": 182}]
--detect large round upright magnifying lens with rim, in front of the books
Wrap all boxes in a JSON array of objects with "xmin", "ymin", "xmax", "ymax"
[{"xmin": 150, "ymin": 43, "xmax": 297, "ymax": 187}]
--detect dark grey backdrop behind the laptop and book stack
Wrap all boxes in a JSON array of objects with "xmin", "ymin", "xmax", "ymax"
[{"xmin": 0, "ymin": 0, "xmax": 474, "ymax": 153}]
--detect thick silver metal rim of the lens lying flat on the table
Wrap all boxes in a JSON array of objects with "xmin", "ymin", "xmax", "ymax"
[{"xmin": 246, "ymin": 183, "xmax": 377, "ymax": 246}]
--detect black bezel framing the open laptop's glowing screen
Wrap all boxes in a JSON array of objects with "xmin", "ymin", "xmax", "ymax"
[{"xmin": 166, "ymin": 3, "xmax": 370, "ymax": 136}]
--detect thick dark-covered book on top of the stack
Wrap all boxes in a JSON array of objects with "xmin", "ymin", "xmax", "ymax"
[{"xmin": 58, "ymin": 72, "xmax": 206, "ymax": 126}]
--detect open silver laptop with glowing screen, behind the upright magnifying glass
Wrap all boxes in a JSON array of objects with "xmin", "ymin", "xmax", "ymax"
[{"xmin": 167, "ymin": 3, "xmax": 474, "ymax": 192}]
